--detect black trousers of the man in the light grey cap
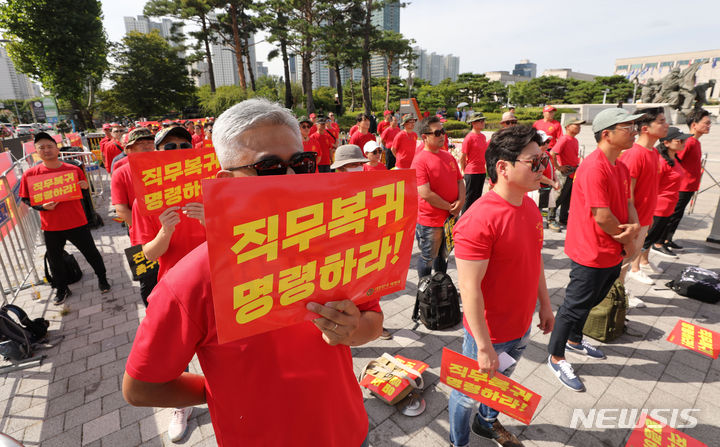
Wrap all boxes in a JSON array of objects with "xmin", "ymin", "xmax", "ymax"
[{"xmin": 548, "ymin": 260, "xmax": 622, "ymax": 357}]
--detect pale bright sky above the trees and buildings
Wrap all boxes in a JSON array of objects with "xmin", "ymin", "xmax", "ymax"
[{"xmin": 102, "ymin": 0, "xmax": 720, "ymax": 75}]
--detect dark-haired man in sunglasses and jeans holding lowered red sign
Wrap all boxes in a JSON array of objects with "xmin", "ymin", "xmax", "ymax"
[{"xmin": 448, "ymin": 126, "xmax": 554, "ymax": 447}]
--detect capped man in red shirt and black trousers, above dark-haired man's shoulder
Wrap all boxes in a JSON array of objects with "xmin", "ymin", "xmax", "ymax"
[{"xmin": 460, "ymin": 112, "xmax": 487, "ymax": 213}]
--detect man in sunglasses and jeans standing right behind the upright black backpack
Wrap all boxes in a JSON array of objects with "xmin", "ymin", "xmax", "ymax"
[{"xmin": 410, "ymin": 116, "xmax": 465, "ymax": 279}]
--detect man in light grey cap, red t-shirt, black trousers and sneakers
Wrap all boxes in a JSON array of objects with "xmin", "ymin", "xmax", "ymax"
[{"xmin": 547, "ymin": 108, "xmax": 643, "ymax": 391}]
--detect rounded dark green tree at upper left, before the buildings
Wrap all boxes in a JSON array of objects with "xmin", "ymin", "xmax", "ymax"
[{"xmin": 110, "ymin": 31, "xmax": 195, "ymax": 116}]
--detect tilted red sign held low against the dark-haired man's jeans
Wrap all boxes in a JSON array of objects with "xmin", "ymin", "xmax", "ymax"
[{"xmin": 440, "ymin": 348, "xmax": 542, "ymax": 424}]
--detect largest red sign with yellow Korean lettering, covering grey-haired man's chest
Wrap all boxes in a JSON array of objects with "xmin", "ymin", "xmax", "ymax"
[{"xmin": 203, "ymin": 170, "xmax": 417, "ymax": 343}]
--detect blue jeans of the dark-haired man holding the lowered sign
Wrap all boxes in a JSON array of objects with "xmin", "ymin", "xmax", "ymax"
[{"xmin": 448, "ymin": 328, "xmax": 530, "ymax": 447}]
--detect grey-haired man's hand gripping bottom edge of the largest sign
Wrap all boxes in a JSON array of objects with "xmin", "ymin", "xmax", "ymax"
[{"xmin": 306, "ymin": 300, "xmax": 361, "ymax": 346}]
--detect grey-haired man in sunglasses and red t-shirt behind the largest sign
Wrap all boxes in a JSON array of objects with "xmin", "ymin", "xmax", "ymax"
[{"xmin": 123, "ymin": 98, "xmax": 383, "ymax": 447}]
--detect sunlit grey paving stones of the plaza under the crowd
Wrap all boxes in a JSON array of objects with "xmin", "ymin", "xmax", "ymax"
[{"xmin": 0, "ymin": 126, "xmax": 720, "ymax": 447}]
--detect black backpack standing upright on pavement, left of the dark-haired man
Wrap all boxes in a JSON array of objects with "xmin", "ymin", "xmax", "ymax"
[{"xmin": 412, "ymin": 272, "xmax": 462, "ymax": 330}]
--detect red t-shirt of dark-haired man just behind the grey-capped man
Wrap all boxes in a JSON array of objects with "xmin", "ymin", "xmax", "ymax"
[{"xmin": 620, "ymin": 143, "xmax": 660, "ymax": 227}]
